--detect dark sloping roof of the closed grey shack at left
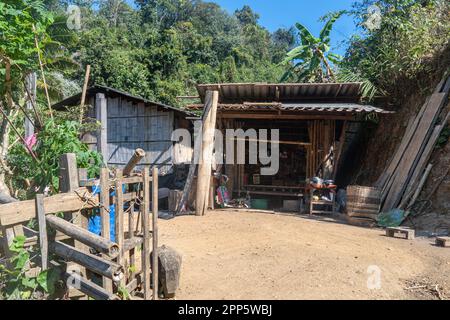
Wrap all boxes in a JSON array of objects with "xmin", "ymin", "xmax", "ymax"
[{"xmin": 52, "ymin": 85, "xmax": 194, "ymax": 116}]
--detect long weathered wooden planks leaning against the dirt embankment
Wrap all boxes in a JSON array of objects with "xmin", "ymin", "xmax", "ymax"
[{"xmin": 375, "ymin": 75, "xmax": 450, "ymax": 212}]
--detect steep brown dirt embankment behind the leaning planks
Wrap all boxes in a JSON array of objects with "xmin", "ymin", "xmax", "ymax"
[{"xmin": 352, "ymin": 48, "xmax": 450, "ymax": 234}]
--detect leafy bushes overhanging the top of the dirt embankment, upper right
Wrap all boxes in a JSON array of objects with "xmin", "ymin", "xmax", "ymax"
[{"xmin": 340, "ymin": 0, "xmax": 450, "ymax": 98}]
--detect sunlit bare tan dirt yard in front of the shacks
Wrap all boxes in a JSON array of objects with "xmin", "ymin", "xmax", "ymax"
[{"xmin": 159, "ymin": 210, "xmax": 450, "ymax": 299}]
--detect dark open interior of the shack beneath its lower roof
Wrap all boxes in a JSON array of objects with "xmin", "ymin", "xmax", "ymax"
[{"xmin": 217, "ymin": 117, "xmax": 346, "ymax": 212}]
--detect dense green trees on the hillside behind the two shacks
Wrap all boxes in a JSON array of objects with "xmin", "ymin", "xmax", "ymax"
[{"xmin": 48, "ymin": 0, "xmax": 294, "ymax": 104}]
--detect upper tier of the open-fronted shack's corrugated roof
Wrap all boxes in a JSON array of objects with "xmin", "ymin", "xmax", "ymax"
[{"xmin": 197, "ymin": 82, "xmax": 361, "ymax": 103}]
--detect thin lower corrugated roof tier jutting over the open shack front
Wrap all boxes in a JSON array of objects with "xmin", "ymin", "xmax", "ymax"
[{"xmin": 188, "ymin": 102, "xmax": 391, "ymax": 113}]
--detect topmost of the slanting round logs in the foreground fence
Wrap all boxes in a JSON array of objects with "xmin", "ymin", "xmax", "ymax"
[{"xmin": 46, "ymin": 215, "xmax": 119, "ymax": 258}]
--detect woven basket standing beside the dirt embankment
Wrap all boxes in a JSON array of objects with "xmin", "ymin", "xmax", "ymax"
[{"xmin": 347, "ymin": 186, "xmax": 381, "ymax": 220}]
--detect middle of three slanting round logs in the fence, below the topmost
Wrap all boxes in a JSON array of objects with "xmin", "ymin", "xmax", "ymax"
[{"xmin": 50, "ymin": 241, "xmax": 123, "ymax": 282}]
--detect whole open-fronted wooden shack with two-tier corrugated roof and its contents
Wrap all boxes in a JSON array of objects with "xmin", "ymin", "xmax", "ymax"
[{"xmin": 187, "ymin": 83, "xmax": 385, "ymax": 214}]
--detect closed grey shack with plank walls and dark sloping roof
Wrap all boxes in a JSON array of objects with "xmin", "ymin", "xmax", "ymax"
[{"xmin": 53, "ymin": 85, "xmax": 192, "ymax": 175}]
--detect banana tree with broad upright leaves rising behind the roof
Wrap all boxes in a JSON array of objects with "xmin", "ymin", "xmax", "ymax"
[{"xmin": 281, "ymin": 11, "xmax": 344, "ymax": 82}]
